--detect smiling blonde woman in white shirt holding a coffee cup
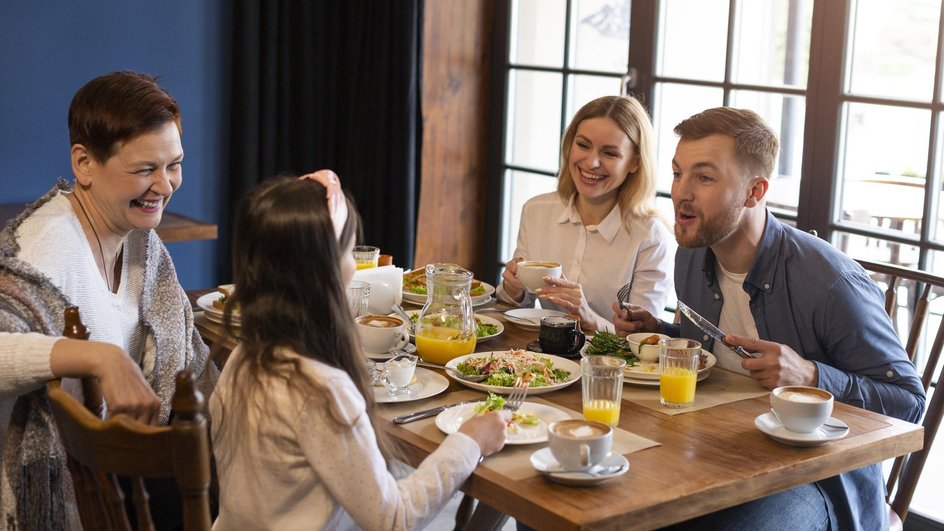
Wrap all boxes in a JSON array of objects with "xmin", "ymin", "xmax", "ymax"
[{"xmin": 498, "ymin": 96, "xmax": 676, "ymax": 331}]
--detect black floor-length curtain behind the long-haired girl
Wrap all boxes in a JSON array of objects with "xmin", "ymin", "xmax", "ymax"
[{"xmin": 228, "ymin": 0, "xmax": 423, "ymax": 272}]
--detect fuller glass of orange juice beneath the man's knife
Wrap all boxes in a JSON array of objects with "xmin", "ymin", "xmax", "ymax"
[{"xmin": 659, "ymin": 338, "xmax": 701, "ymax": 407}]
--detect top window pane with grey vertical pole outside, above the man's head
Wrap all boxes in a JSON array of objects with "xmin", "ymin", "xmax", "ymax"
[{"xmin": 731, "ymin": 0, "xmax": 813, "ymax": 87}]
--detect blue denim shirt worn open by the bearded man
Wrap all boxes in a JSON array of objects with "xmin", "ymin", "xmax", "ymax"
[{"xmin": 666, "ymin": 211, "xmax": 925, "ymax": 530}]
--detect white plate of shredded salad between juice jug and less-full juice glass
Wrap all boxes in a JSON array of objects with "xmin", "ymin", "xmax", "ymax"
[{"xmin": 446, "ymin": 349, "xmax": 581, "ymax": 395}]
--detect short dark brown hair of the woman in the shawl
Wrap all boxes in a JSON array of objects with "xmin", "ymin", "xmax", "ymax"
[{"xmin": 69, "ymin": 71, "xmax": 181, "ymax": 162}]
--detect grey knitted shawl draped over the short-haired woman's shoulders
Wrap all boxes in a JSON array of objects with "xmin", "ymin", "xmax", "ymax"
[{"xmin": 0, "ymin": 180, "xmax": 219, "ymax": 529}]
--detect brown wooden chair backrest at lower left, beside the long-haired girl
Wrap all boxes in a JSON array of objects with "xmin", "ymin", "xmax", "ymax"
[{"xmin": 48, "ymin": 371, "xmax": 211, "ymax": 531}]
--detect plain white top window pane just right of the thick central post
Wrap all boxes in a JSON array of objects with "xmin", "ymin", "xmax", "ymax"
[{"xmin": 656, "ymin": 0, "xmax": 729, "ymax": 81}]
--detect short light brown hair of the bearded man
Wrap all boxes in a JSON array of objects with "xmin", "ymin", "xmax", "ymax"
[{"xmin": 675, "ymin": 107, "xmax": 780, "ymax": 179}]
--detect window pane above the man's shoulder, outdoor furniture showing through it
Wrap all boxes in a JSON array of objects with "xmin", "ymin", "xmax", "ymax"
[{"xmin": 836, "ymin": 103, "xmax": 931, "ymax": 234}]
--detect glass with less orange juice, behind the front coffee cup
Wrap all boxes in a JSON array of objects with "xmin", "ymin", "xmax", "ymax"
[{"xmin": 580, "ymin": 355, "xmax": 626, "ymax": 427}]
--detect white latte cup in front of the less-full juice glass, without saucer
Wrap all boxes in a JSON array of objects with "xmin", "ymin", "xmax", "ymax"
[{"xmin": 547, "ymin": 419, "xmax": 613, "ymax": 472}]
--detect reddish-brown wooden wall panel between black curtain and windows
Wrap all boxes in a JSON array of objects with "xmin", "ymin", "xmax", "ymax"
[{"xmin": 414, "ymin": 0, "xmax": 498, "ymax": 273}]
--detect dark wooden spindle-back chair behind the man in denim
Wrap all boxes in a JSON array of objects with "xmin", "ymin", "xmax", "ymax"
[{"xmin": 858, "ymin": 260, "xmax": 944, "ymax": 521}]
